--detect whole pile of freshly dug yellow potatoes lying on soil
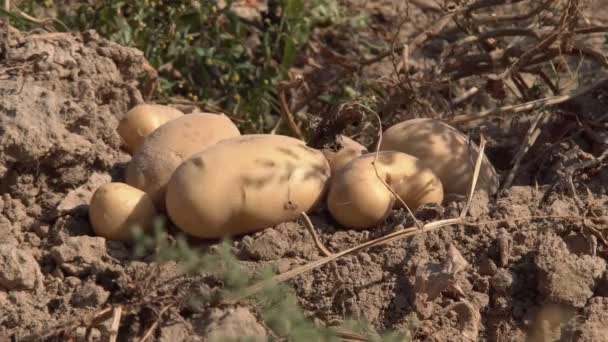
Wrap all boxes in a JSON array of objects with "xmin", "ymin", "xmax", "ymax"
[{"xmin": 89, "ymin": 104, "xmax": 498, "ymax": 240}]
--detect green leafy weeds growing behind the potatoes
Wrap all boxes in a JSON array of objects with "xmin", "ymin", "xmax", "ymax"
[{"xmin": 14, "ymin": 0, "xmax": 344, "ymax": 132}]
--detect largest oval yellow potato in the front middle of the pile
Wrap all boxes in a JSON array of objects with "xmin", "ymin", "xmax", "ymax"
[{"xmin": 167, "ymin": 134, "xmax": 330, "ymax": 239}]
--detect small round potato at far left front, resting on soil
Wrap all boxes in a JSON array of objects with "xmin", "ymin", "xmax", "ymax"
[{"xmin": 89, "ymin": 182, "xmax": 157, "ymax": 240}]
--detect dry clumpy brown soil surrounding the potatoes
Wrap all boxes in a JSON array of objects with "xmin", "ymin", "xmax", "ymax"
[{"xmin": 0, "ymin": 1, "xmax": 608, "ymax": 341}]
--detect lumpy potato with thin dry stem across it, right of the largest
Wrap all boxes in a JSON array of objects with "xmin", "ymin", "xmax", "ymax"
[{"xmin": 327, "ymin": 151, "xmax": 443, "ymax": 229}]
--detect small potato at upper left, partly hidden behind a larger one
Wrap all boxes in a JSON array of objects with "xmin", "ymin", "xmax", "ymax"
[{"xmin": 118, "ymin": 104, "xmax": 184, "ymax": 154}]
